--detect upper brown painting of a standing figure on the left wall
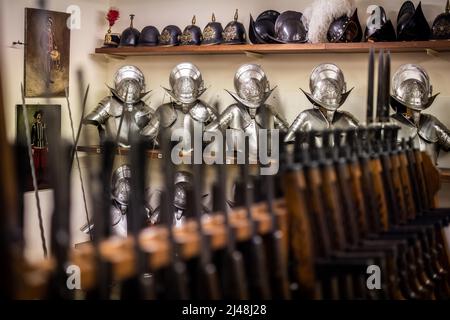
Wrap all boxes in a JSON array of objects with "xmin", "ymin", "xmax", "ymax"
[{"xmin": 24, "ymin": 8, "xmax": 70, "ymax": 98}]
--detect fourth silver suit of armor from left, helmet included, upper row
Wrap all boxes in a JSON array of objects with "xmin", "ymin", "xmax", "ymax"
[{"xmin": 285, "ymin": 63, "xmax": 358, "ymax": 144}]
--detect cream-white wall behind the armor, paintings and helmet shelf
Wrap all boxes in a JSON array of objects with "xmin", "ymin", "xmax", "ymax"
[{"xmin": 0, "ymin": 0, "xmax": 450, "ymax": 258}]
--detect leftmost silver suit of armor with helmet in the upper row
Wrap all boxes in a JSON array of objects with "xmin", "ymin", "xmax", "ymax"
[{"xmin": 83, "ymin": 66, "xmax": 153, "ymax": 147}]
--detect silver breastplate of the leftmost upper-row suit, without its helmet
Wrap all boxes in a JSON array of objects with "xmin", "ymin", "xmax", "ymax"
[{"xmin": 104, "ymin": 99, "xmax": 153, "ymax": 147}]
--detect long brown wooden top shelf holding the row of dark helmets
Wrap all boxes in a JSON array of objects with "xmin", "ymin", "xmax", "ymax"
[{"xmin": 95, "ymin": 40, "xmax": 450, "ymax": 57}]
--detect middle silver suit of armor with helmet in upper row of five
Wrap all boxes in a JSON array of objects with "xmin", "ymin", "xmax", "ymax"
[{"xmin": 207, "ymin": 64, "xmax": 288, "ymax": 158}]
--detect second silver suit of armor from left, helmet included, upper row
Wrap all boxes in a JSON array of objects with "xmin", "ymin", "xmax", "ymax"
[{"xmin": 142, "ymin": 63, "xmax": 217, "ymax": 151}]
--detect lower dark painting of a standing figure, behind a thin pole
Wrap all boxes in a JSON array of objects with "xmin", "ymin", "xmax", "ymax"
[{"xmin": 16, "ymin": 105, "xmax": 61, "ymax": 191}]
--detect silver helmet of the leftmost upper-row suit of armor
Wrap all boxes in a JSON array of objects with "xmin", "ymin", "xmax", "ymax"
[{"xmin": 110, "ymin": 65, "xmax": 147, "ymax": 104}]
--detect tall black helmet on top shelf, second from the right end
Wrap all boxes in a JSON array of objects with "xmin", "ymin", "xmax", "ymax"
[{"xmin": 397, "ymin": 1, "xmax": 431, "ymax": 41}]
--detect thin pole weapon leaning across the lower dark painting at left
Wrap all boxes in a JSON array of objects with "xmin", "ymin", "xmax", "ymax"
[{"xmin": 20, "ymin": 83, "xmax": 48, "ymax": 258}]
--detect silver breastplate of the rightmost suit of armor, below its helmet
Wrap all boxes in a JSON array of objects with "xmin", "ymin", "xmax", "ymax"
[{"xmin": 391, "ymin": 113, "xmax": 439, "ymax": 163}]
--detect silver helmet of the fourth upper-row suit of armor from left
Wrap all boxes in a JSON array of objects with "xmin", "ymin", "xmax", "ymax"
[{"xmin": 302, "ymin": 63, "xmax": 351, "ymax": 111}]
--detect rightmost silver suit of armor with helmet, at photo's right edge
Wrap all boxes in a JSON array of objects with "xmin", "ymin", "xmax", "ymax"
[{"xmin": 391, "ymin": 64, "xmax": 450, "ymax": 163}]
